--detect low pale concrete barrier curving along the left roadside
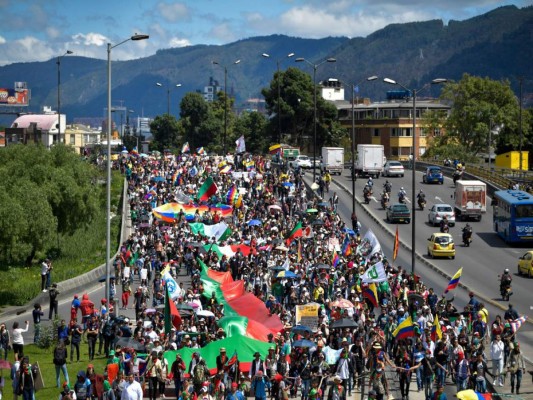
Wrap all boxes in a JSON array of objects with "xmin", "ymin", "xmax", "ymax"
[{"xmin": 0, "ymin": 179, "xmax": 131, "ymax": 319}]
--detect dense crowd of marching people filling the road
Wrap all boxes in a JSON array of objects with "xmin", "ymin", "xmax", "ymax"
[{"xmin": 0, "ymin": 150, "xmax": 525, "ymax": 400}]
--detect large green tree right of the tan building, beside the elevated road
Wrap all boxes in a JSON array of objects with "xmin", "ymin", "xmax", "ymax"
[{"xmin": 441, "ymin": 74, "xmax": 528, "ymax": 154}]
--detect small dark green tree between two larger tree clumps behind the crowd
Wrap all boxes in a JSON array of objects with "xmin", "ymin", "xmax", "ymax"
[{"xmin": 231, "ymin": 111, "xmax": 269, "ymax": 154}]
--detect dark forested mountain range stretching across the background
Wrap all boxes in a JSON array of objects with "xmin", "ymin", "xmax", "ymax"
[{"xmin": 0, "ymin": 6, "xmax": 533, "ymax": 124}]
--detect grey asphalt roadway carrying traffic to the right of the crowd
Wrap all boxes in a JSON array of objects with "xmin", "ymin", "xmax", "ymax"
[{"xmin": 304, "ymin": 173, "xmax": 533, "ymax": 360}]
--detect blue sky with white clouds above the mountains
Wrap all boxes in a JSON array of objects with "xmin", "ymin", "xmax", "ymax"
[{"xmin": 0, "ymin": 0, "xmax": 532, "ymax": 65}]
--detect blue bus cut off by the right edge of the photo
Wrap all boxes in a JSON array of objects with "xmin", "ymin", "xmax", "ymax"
[{"xmin": 492, "ymin": 190, "xmax": 533, "ymax": 243}]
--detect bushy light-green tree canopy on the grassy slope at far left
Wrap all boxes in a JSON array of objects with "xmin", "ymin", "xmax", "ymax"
[{"xmin": 0, "ymin": 145, "xmax": 99, "ymax": 263}]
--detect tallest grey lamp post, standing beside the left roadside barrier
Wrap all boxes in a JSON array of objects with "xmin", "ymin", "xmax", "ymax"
[{"xmin": 105, "ymin": 34, "xmax": 150, "ymax": 300}]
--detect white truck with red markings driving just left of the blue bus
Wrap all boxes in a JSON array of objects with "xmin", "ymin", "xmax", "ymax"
[{"xmin": 454, "ymin": 180, "xmax": 487, "ymax": 221}]
